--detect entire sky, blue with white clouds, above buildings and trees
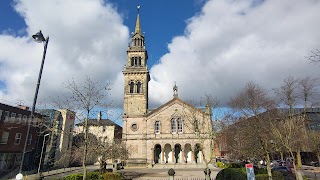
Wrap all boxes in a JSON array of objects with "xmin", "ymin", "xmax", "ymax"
[{"xmin": 0, "ymin": 0, "xmax": 320, "ymax": 115}]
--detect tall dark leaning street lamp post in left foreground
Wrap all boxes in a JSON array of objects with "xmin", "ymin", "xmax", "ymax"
[{"xmin": 19, "ymin": 30, "xmax": 49, "ymax": 174}]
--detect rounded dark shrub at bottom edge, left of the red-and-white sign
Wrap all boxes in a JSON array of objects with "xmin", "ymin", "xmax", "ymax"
[{"xmin": 216, "ymin": 168, "xmax": 247, "ymax": 180}]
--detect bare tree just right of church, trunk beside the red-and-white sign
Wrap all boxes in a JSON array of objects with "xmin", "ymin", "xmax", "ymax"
[{"xmin": 229, "ymin": 82, "xmax": 274, "ymax": 179}]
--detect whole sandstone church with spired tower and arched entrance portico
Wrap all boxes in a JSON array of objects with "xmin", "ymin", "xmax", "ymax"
[{"xmin": 122, "ymin": 8, "xmax": 213, "ymax": 166}]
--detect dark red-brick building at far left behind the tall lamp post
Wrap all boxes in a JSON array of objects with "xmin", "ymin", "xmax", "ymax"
[{"xmin": 0, "ymin": 103, "xmax": 41, "ymax": 173}]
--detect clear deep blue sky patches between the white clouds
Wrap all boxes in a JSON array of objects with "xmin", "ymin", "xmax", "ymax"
[{"xmin": 0, "ymin": 0, "xmax": 205, "ymax": 69}]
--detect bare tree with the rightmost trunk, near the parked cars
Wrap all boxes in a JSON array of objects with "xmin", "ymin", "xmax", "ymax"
[{"xmin": 272, "ymin": 76, "xmax": 313, "ymax": 179}]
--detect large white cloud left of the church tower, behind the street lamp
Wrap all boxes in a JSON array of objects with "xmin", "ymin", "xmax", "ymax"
[{"xmin": 0, "ymin": 0, "xmax": 129, "ymax": 108}]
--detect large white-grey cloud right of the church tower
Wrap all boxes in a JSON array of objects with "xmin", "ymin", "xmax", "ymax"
[{"xmin": 150, "ymin": 0, "xmax": 320, "ymax": 107}]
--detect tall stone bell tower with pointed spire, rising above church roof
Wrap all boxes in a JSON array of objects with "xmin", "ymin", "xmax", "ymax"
[{"xmin": 122, "ymin": 6, "xmax": 150, "ymax": 117}]
